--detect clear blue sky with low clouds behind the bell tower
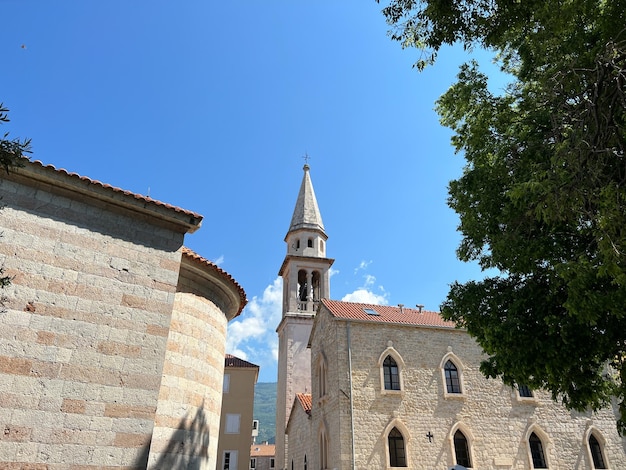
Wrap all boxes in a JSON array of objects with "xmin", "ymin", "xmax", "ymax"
[{"xmin": 0, "ymin": 0, "xmax": 502, "ymax": 382}]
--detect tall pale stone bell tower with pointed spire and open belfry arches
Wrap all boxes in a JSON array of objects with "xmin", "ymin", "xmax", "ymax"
[{"xmin": 276, "ymin": 164, "xmax": 334, "ymax": 470}]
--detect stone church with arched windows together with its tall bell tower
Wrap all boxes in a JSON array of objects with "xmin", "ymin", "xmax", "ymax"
[{"xmin": 276, "ymin": 165, "xmax": 626, "ymax": 470}]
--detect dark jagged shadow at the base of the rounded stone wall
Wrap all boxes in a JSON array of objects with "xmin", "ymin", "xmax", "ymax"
[{"xmin": 133, "ymin": 402, "xmax": 210, "ymax": 470}]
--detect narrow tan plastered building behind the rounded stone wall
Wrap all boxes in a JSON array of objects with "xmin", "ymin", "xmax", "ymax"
[{"xmin": 217, "ymin": 354, "xmax": 259, "ymax": 470}]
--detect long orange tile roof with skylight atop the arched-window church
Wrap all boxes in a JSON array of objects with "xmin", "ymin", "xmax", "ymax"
[{"xmin": 322, "ymin": 299, "xmax": 455, "ymax": 328}]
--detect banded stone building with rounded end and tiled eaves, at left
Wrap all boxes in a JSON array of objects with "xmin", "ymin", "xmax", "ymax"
[{"xmin": 0, "ymin": 161, "xmax": 246, "ymax": 470}]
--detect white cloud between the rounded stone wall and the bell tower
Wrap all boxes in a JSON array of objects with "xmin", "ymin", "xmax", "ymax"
[{"xmin": 226, "ymin": 277, "xmax": 283, "ymax": 378}]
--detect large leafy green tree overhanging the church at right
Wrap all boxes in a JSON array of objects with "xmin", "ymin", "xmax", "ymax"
[{"xmin": 376, "ymin": 0, "xmax": 626, "ymax": 434}]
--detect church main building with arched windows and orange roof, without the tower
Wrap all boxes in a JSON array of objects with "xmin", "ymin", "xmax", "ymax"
[{"xmin": 304, "ymin": 299, "xmax": 626, "ymax": 470}]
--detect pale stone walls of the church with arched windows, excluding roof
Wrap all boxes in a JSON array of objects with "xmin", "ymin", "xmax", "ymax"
[{"xmin": 312, "ymin": 308, "xmax": 626, "ymax": 470}]
